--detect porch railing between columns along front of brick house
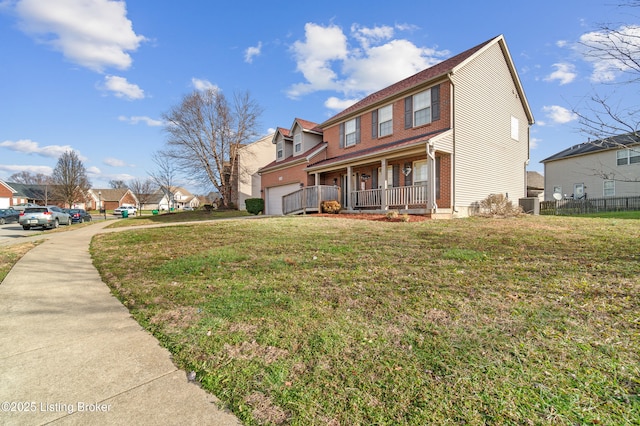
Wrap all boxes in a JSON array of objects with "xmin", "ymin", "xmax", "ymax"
[{"xmin": 350, "ymin": 185, "xmax": 428, "ymax": 209}]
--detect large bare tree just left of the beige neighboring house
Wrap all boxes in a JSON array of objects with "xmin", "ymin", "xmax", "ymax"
[{"xmin": 163, "ymin": 89, "xmax": 262, "ymax": 207}]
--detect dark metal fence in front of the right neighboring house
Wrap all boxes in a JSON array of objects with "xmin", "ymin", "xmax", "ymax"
[{"xmin": 540, "ymin": 196, "xmax": 640, "ymax": 215}]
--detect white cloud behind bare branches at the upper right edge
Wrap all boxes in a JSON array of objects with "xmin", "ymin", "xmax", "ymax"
[{"xmin": 578, "ymin": 25, "xmax": 640, "ymax": 83}]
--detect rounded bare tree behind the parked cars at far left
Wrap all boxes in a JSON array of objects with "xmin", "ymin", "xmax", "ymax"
[{"xmin": 51, "ymin": 151, "xmax": 91, "ymax": 207}]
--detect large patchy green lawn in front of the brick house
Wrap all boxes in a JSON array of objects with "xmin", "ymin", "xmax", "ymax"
[{"xmin": 91, "ymin": 216, "xmax": 640, "ymax": 425}]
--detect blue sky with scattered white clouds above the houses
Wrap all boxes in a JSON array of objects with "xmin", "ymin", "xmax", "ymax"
[{"xmin": 0, "ymin": 0, "xmax": 638, "ymax": 192}]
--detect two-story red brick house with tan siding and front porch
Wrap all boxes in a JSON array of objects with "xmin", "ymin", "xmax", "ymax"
[{"xmin": 260, "ymin": 36, "xmax": 534, "ymax": 217}]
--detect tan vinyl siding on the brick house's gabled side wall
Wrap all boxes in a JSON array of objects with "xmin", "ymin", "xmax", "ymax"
[{"xmin": 452, "ymin": 43, "xmax": 529, "ymax": 209}]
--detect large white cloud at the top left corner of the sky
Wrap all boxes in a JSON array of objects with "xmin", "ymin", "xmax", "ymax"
[{"xmin": 15, "ymin": 0, "xmax": 146, "ymax": 72}]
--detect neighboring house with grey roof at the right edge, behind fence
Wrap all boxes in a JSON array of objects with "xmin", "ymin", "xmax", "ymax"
[{"xmin": 541, "ymin": 134, "xmax": 640, "ymax": 201}]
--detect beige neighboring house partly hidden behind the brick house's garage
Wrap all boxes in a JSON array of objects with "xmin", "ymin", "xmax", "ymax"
[{"xmin": 235, "ymin": 133, "xmax": 275, "ymax": 210}]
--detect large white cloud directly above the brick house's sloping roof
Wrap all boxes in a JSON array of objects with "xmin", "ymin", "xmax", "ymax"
[{"xmin": 287, "ymin": 23, "xmax": 449, "ymax": 105}]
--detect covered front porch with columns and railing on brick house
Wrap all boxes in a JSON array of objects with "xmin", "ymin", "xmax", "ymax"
[{"xmin": 283, "ymin": 142, "xmax": 451, "ymax": 215}]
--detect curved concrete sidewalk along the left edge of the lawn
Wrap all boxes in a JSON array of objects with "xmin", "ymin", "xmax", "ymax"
[{"xmin": 0, "ymin": 222, "xmax": 240, "ymax": 426}]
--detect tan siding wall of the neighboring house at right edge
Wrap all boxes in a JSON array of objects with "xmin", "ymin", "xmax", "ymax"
[{"xmin": 544, "ymin": 149, "xmax": 640, "ymax": 201}]
